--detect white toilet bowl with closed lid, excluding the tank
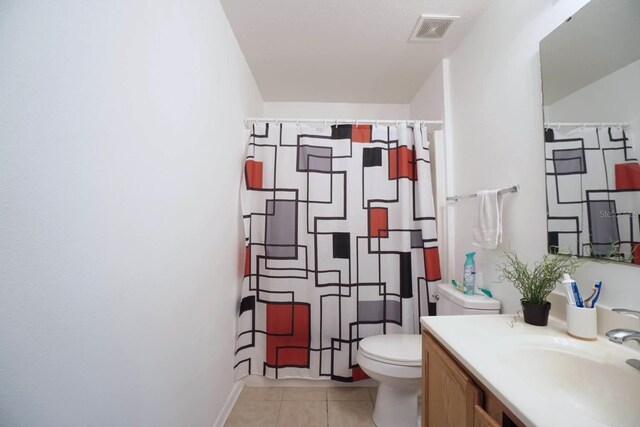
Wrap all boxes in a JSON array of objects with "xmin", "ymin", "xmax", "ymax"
[{"xmin": 357, "ymin": 335, "xmax": 422, "ymax": 427}]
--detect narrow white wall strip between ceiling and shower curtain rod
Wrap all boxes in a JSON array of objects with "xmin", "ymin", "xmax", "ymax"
[{"xmin": 264, "ymin": 102, "xmax": 410, "ymax": 120}]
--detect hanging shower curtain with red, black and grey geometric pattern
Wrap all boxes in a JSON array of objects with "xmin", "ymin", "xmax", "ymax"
[{"xmin": 235, "ymin": 123, "xmax": 441, "ymax": 381}]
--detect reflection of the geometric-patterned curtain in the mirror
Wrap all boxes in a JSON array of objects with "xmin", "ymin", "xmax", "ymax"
[{"xmin": 545, "ymin": 127, "xmax": 640, "ymax": 264}]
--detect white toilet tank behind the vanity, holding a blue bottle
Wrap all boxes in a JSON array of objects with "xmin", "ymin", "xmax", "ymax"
[{"xmin": 436, "ymin": 283, "xmax": 500, "ymax": 316}]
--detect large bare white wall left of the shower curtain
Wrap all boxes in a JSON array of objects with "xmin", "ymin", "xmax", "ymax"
[{"xmin": 0, "ymin": 0, "xmax": 262, "ymax": 427}]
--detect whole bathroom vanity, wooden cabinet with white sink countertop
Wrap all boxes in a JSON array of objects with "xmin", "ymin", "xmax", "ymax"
[{"xmin": 421, "ymin": 315, "xmax": 640, "ymax": 427}]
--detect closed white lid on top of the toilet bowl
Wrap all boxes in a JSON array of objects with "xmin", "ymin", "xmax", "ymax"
[{"xmin": 360, "ymin": 334, "xmax": 422, "ymax": 366}]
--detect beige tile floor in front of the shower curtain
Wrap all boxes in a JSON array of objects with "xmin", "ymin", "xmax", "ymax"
[{"xmin": 225, "ymin": 387, "xmax": 377, "ymax": 427}]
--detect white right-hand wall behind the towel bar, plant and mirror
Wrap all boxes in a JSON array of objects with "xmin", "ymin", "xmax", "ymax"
[{"xmin": 445, "ymin": 0, "xmax": 640, "ymax": 312}]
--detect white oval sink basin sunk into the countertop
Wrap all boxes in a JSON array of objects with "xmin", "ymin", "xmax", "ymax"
[{"xmin": 501, "ymin": 341, "xmax": 640, "ymax": 426}]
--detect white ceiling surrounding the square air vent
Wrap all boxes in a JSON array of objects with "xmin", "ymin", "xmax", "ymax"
[{"xmin": 220, "ymin": 0, "xmax": 490, "ymax": 103}]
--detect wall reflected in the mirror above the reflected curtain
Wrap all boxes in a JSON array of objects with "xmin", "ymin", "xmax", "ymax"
[{"xmin": 545, "ymin": 60, "xmax": 640, "ymax": 152}]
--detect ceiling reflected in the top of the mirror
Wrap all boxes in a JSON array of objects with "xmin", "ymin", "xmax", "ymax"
[{"xmin": 540, "ymin": 0, "xmax": 640, "ymax": 105}]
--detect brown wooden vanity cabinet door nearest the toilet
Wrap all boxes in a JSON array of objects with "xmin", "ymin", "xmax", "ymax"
[{"xmin": 423, "ymin": 334, "xmax": 482, "ymax": 427}]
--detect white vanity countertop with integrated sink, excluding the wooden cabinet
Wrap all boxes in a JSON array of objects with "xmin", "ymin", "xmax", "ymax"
[{"xmin": 420, "ymin": 315, "xmax": 640, "ymax": 427}]
